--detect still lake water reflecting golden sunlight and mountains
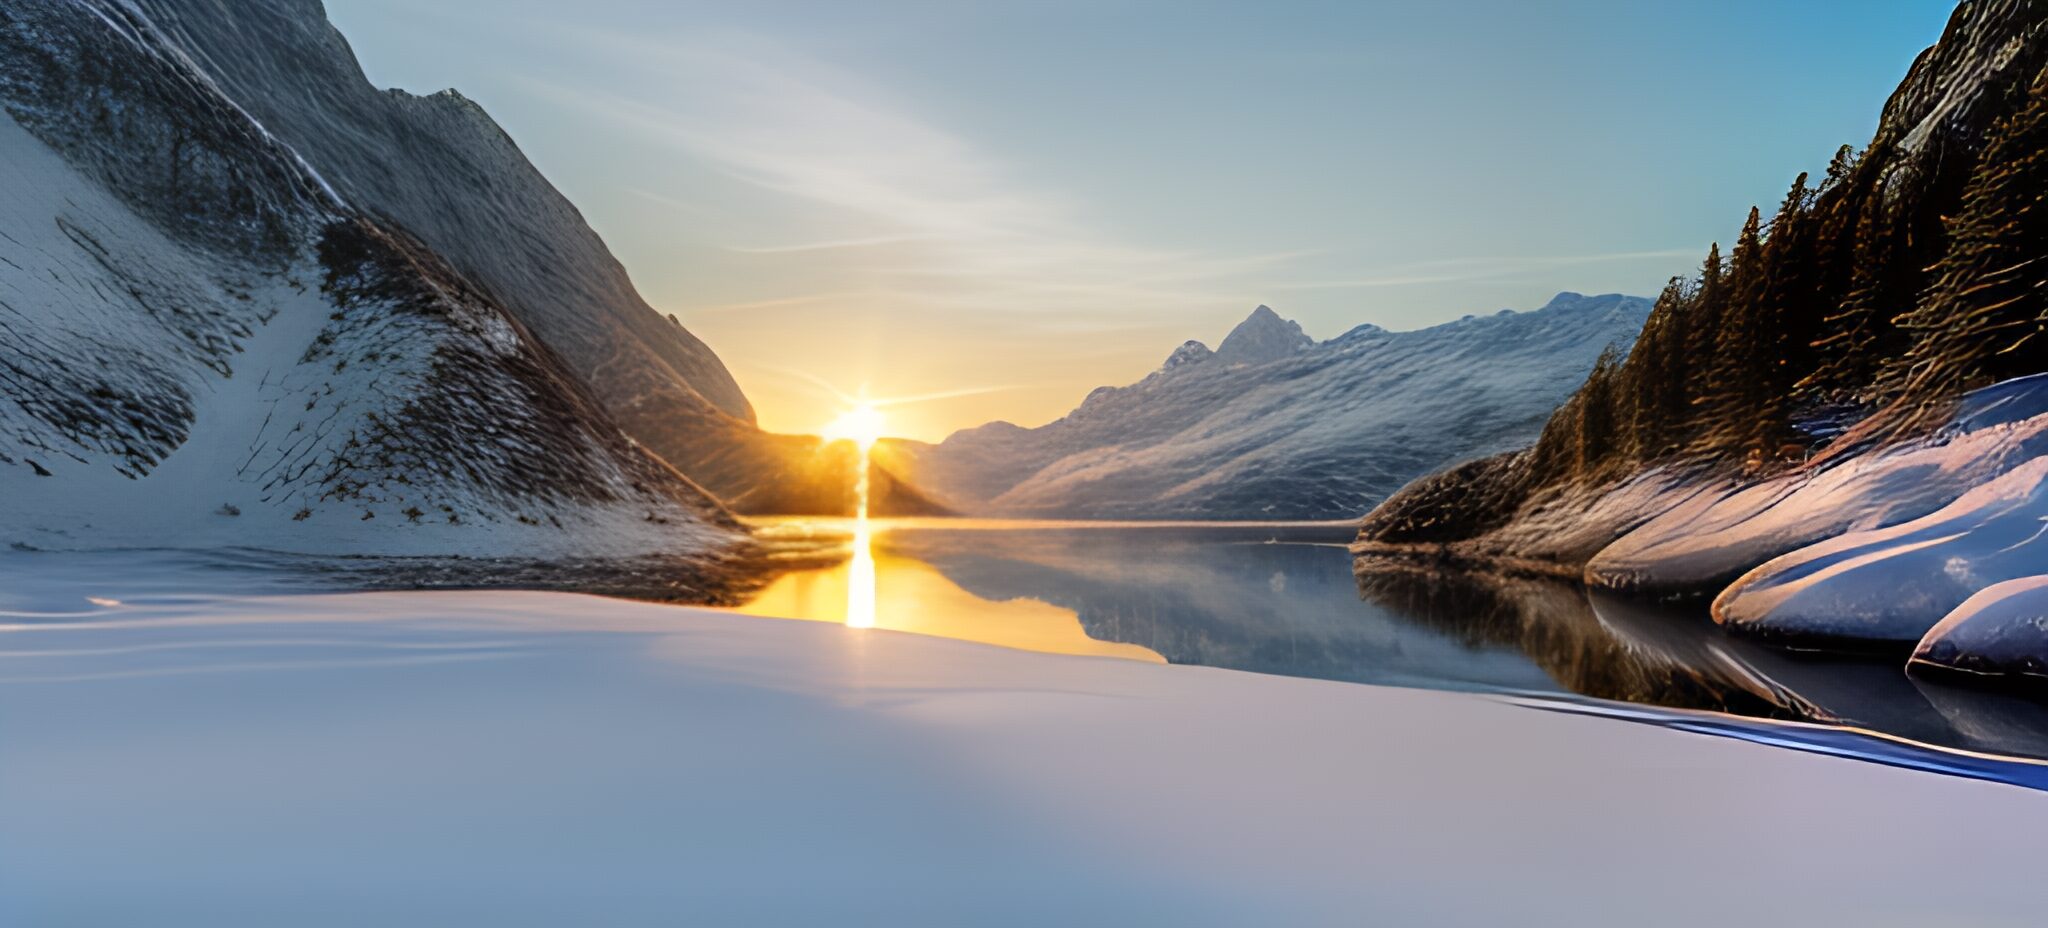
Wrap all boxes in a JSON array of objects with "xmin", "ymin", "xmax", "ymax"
[{"xmin": 743, "ymin": 520, "xmax": 2048, "ymax": 756}]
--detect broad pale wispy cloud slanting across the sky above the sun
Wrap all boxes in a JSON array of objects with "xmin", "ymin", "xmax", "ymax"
[{"xmin": 524, "ymin": 31, "xmax": 1303, "ymax": 309}]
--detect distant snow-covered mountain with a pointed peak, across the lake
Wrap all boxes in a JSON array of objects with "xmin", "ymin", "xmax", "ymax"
[{"xmin": 905, "ymin": 293, "xmax": 1649, "ymax": 518}]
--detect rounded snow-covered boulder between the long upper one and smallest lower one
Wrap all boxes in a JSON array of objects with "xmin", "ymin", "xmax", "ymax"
[{"xmin": 1714, "ymin": 454, "xmax": 2048, "ymax": 645}]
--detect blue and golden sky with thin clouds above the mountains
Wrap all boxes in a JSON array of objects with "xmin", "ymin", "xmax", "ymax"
[{"xmin": 328, "ymin": 0, "xmax": 1952, "ymax": 438}]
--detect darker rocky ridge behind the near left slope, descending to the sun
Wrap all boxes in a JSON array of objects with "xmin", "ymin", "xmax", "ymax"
[{"xmin": 102, "ymin": 0, "xmax": 936, "ymax": 514}]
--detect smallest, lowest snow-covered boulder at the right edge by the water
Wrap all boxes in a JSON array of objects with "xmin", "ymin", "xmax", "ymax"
[{"xmin": 1909, "ymin": 573, "xmax": 2048, "ymax": 688}]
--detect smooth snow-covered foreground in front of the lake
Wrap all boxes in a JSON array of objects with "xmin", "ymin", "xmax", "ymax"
[{"xmin": 0, "ymin": 561, "xmax": 2048, "ymax": 928}]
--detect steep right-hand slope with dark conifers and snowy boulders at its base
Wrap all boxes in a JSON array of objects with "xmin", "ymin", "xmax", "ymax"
[{"xmin": 1356, "ymin": 0, "xmax": 2048, "ymax": 692}]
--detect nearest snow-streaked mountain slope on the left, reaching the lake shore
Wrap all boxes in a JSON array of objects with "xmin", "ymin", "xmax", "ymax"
[{"xmin": 0, "ymin": 0, "xmax": 741, "ymax": 555}]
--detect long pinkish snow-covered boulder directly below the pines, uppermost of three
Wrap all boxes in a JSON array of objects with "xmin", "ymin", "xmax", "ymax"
[{"xmin": 1585, "ymin": 377, "xmax": 2048, "ymax": 594}]
